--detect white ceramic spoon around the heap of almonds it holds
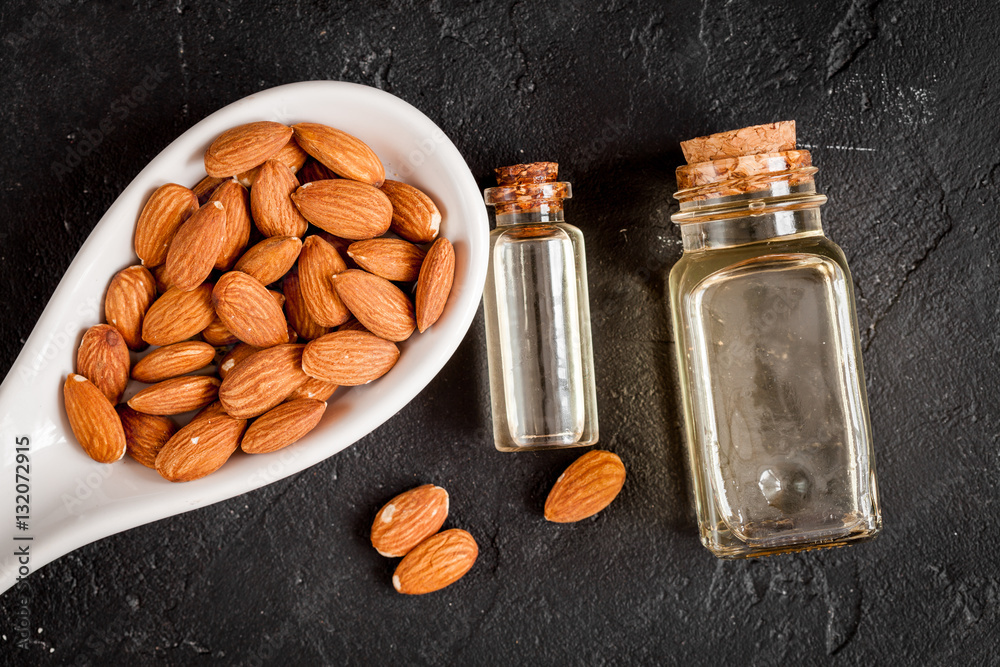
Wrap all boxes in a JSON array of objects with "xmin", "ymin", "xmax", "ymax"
[{"xmin": 0, "ymin": 81, "xmax": 489, "ymax": 591}]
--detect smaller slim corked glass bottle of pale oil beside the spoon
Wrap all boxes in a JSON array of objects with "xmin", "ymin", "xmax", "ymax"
[{"xmin": 483, "ymin": 162, "xmax": 597, "ymax": 452}]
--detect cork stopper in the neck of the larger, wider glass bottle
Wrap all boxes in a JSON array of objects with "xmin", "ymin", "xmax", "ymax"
[{"xmin": 675, "ymin": 120, "xmax": 816, "ymax": 202}]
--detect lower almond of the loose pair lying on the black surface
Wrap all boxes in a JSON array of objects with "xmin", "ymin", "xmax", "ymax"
[{"xmin": 392, "ymin": 528, "xmax": 479, "ymax": 595}]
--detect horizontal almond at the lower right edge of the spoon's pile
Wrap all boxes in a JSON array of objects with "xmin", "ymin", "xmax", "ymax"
[{"xmin": 302, "ymin": 331, "xmax": 399, "ymax": 387}]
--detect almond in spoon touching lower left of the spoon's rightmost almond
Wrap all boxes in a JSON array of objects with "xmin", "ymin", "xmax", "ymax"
[{"xmin": 331, "ymin": 269, "xmax": 417, "ymax": 342}]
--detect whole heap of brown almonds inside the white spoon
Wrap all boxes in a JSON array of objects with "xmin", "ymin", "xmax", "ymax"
[{"xmin": 63, "ymin": 121, "xmax": 455, "ymax": 482}]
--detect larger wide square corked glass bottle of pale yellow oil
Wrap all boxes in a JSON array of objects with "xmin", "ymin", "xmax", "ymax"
[{"xmin": 670, "ymin": 122, "xmax": 882, "ymax": 558}]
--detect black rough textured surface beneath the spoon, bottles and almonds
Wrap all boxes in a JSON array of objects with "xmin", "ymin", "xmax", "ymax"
[{"xmin": 0, "ymin": 0, "xmax": 1000, "ymax": 665}]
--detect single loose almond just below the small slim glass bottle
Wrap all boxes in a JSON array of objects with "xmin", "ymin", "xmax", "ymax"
[{"xmin": 545, "ymin": 449, "xmax": 625, "ymax": 523}]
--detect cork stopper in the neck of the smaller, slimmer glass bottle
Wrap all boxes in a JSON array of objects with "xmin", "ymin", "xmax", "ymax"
[{"xmin": 483, "ymin": 162, "xmax": 573, "ymax": 215}]
